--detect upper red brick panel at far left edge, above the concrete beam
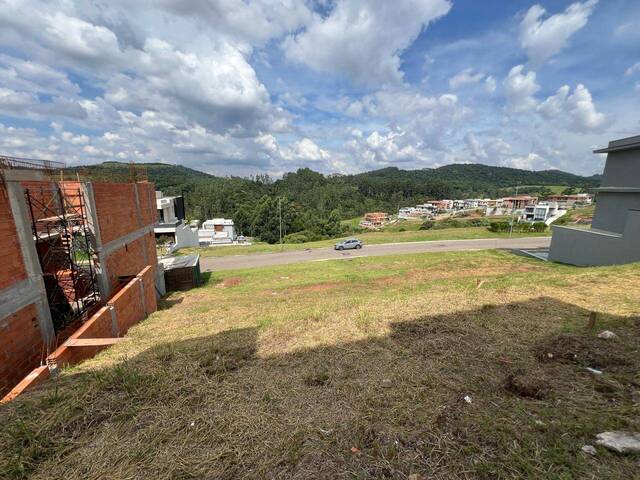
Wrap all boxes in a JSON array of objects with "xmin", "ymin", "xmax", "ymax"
[{"xmin": 0, "ymin": 188, "xmax": 27, "ymax": 289}]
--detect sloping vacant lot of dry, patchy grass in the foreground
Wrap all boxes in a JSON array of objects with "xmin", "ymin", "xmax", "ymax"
[{"xmin": 0, "ymin": 251, "xmax": 640, "ymax": 479}]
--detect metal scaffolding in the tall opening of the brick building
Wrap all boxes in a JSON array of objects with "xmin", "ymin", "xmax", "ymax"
[{"xmin": 25, "ymin": 183, "xmax": 101, "ymax": 332}]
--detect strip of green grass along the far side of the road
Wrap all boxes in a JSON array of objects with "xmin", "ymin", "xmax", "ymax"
[{"xmin": 176, "ymin": 226, "xmax": 549, "ymax": 257}]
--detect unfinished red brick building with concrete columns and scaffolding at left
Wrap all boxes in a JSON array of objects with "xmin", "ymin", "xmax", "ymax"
[{"xmin": 0, "ymin": 157, "xmax": 157, "ymax": 397}]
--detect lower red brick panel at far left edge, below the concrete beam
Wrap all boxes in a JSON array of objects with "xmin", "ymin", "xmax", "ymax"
[{"xmin": 0, "ymin": 304, "xmax": 46, "ymax": 394}]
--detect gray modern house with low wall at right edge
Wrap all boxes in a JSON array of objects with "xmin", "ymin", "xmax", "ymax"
[{"xmin": 549, "ymin": 135, "xmax": 640, "ymax": 266}]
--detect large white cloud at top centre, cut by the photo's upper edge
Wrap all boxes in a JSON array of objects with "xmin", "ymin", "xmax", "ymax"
[{"xmin": 283, "ymin": 0, "xmax": 451, "ymax": 85}]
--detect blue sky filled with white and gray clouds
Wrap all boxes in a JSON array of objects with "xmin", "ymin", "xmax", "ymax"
[{"xmin": 0, "ymin": 0, "xmax": 640, "ymax": 176}]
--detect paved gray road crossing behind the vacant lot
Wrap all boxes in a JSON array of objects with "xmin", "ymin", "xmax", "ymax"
[{"xmin": 200, "ymin": 237, "xmax": 551, "ymax": 272}]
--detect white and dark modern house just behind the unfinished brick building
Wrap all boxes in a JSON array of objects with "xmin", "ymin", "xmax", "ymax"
[{"xmin": 153, "ymin": 190, "xmax": 198, "ymax": 252}]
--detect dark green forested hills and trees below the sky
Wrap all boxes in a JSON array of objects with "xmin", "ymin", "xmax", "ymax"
[{"xmin": 69, "ymin": 162, "xmax": 599, "ymax": 243}]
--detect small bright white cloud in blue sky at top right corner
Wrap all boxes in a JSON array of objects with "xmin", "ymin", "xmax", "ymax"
[{"xmin": 520, "ymin": 0, "xmax": 598, "ymax": 67}]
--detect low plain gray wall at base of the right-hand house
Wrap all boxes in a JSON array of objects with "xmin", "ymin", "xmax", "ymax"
[{"xmin": 549, "ymin": 210, "xmax": 640, "ymax": 266}]
